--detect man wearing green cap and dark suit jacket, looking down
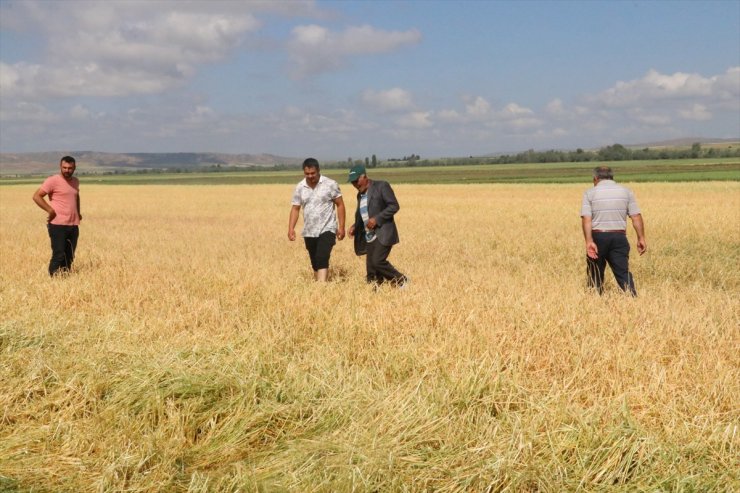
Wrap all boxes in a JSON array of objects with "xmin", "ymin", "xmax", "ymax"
[{"xmin": 348, "ymin": 166, "xmax": 408, "ymax": 287}]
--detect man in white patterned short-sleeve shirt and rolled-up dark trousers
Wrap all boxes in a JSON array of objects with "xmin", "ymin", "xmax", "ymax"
[{"xmin": 288, "ymin": 158, "xmax": 345, "ymax": 282}]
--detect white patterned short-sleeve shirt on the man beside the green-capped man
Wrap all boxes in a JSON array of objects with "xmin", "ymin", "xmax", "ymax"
[{"xmin": 291, "ymin": 175, "xmax": 342, "ymax": 238}]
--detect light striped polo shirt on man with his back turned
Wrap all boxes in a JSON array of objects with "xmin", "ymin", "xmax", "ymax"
[{"xmin": 581, "ymin": 180, "xmax": 640, "ymax": 231}]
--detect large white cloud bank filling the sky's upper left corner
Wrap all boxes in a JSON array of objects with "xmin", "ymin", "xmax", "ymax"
[{"xmin": 0, "ymin": 1, "xmax": 268, "ymax": 101}]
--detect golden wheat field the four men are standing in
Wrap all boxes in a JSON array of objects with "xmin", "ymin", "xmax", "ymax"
[{"xmin": 0, "ymin": 182, "xmax": 740, "ymax": 492}]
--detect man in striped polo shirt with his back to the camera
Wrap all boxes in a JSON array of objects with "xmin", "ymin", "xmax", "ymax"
[{"xmin": 581, "ymin": 166, "xmax": 647, "ymax": 296}]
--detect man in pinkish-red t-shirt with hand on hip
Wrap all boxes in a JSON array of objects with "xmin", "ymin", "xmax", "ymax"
[{"xmin": 33, "ymin": 156, "xmax": 82, "ymax": 276}]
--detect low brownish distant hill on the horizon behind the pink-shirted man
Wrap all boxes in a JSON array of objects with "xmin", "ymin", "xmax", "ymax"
[{"xmin": 0, "ymin": 151, "xmax": 302, "ymax": 175}]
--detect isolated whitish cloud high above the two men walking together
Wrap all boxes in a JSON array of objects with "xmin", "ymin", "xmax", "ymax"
[{"xmin": 287, "ymin": 24, "xmax": 421, "ymax": 77}]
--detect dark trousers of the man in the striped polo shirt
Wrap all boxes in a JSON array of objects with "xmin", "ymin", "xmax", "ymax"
[{"xmin": 586, "ymin": 233, "xmax": 637, "ymax": 296}]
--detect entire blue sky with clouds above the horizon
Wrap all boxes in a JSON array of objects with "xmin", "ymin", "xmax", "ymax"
[{"xmin": 0, "ymin": 0, "xmax": 740, "ymax": 160}]
